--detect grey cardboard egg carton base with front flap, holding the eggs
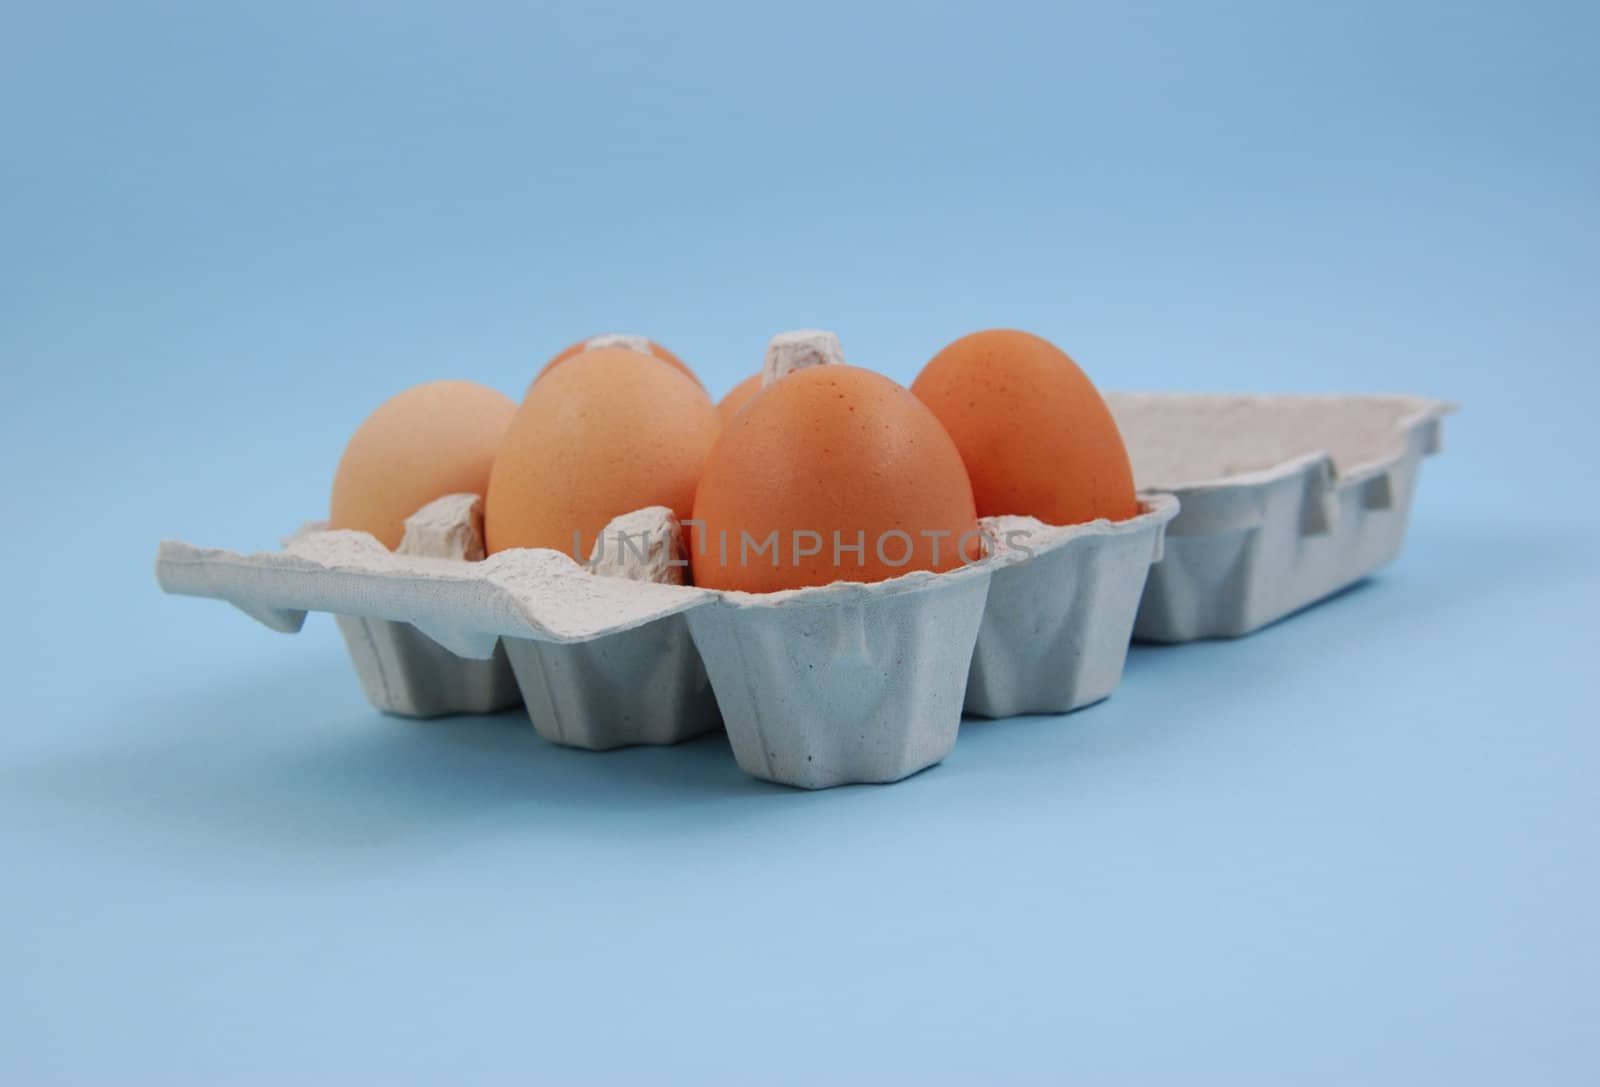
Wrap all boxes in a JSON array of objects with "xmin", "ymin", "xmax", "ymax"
[{"xmin": 155, "ymin": 495, "xmax": 1176, "ymax": 789}]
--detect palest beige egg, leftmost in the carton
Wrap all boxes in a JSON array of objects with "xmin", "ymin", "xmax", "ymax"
[{"xmin": 328, "ymin": 381, "xmax": 517, "ymax": 551}]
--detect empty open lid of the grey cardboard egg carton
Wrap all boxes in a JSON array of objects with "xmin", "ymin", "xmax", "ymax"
[{"xmin": 1106, "ymin": 392, "xmax": 1454, "ymax": 642}]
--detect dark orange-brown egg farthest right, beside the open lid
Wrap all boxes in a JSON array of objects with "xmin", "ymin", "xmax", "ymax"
[{"xmin": 910, "ymin": 328, "xmax": 1139, "ymax": 525}]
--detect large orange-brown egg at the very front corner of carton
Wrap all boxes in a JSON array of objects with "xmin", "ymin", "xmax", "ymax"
[{"xmin": 690, "ymin": 365, "xmax": 981, "ymax": 592}]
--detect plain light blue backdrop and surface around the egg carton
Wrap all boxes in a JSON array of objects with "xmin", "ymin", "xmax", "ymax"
[{"xmin": 0, "ymin": 2, "xmax": 1600, "ymax": 1084}]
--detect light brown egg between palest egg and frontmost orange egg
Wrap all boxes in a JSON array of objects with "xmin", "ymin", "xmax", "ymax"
[{"xmin": 483, "ymin": 347, "xmax": 722, "ymax": 560}]
